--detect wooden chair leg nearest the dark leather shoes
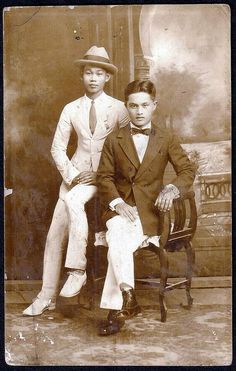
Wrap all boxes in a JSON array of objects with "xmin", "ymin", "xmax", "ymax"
[{"xmin": 158, "ymin": 247, "xmax": 169, "ymax": 322}]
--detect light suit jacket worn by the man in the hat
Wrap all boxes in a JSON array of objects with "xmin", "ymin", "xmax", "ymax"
[{"xmin": 51, "ymin": 93, "xmax": 129, "ymax": 186}]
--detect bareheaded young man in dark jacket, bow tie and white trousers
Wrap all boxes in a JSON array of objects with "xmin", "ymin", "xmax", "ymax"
[{"xmin": 97, "ymin": 80, "xmax": 195, "ymax": 335}]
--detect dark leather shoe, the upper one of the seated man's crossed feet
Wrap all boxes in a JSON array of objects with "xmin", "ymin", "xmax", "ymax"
[{"xmin": 107, "ymin": 289, "xmax": 141, "ymax": 321}]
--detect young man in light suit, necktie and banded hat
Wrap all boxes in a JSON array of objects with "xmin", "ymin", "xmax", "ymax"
[{"xmin": 23, "ymin": 46, "xmax": 128, "ymax": 316}]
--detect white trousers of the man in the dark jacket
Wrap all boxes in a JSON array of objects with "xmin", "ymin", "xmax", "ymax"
[{"xmin": 100, "ymin": 214, "xmax": 147, "ymax": 310}]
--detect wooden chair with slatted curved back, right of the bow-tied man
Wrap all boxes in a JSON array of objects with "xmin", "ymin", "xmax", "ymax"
[{"xmin": 135, "ymin": 191, "xmax": 197, "ymax": 322}]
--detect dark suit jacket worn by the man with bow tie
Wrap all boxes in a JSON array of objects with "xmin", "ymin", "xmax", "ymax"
[{"xmin": 97, "ymin": 123, "xmax": 195, "ymax": 236}]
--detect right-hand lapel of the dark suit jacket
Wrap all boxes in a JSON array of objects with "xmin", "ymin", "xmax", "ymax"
[{"xmin": 135, "ymin": 123, "xmax": 165, "ymax": 179}]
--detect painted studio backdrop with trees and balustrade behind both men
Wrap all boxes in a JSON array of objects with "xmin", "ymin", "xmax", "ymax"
[{"xmin": 4, "ymin": 5, "xmax": 231, "ymax": 280}]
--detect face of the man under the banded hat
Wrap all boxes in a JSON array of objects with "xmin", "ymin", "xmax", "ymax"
[{"xmin": 82, "ymin": 65, "xmax": 110, "ymax": 95}]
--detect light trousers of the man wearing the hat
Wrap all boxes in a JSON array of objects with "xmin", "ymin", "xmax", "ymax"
[{"xmin": 38, "ymin": 184, "xmax": 97, "ymax": 300}]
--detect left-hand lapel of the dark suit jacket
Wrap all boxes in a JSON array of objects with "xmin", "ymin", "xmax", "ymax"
[{"xmin": 117, "ymin": 125, "xmax": 140, "ymax": 169}]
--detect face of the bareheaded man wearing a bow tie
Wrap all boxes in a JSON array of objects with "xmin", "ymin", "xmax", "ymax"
[{"xmin": 126, "ymin": 92, "xmax": 157, "ymax": 127}]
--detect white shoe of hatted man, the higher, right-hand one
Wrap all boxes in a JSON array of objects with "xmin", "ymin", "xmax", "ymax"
[{"xmin": 59, "ymin": 271, "xmax": 87, "ymax": 298}]
